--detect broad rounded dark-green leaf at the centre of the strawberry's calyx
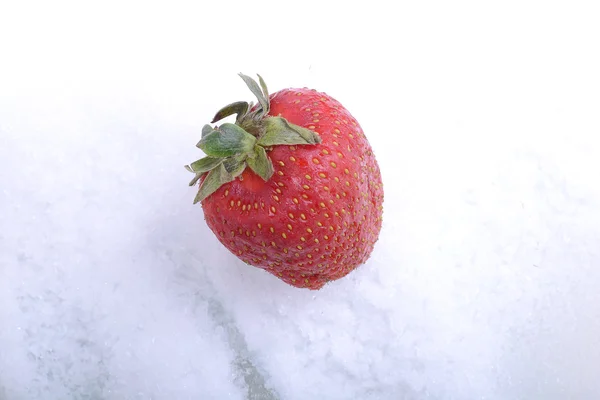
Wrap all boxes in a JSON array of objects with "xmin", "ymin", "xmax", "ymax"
[{"xmin": 197, "ymin": 123, "xmax": 256, "ymax": 157}]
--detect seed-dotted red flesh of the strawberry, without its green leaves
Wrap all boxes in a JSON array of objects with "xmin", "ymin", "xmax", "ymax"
[{"xmin": 202, "ymin": 89, "xmax": 383, "ymax": 289}]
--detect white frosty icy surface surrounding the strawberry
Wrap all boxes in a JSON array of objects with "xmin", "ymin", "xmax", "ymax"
[{"xmin": 0, "ymin": 1, "xmax": 600, "ymax": 400}]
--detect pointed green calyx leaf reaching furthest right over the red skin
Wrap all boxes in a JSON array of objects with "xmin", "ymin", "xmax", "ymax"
[{"xmin": 258, "ymin": 117, "xmax": 321, "ymax": 147}]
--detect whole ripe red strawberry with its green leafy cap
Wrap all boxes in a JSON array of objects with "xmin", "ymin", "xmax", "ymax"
[{"xmin": 186, "ymin": 74, "xmax": 383, "ymax": 290}]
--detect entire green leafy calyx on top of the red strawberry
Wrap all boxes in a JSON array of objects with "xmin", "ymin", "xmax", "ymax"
[{"xmin": 185, "ymin": 74, "xmax": 321, "ymax": 204}]
